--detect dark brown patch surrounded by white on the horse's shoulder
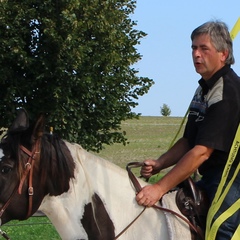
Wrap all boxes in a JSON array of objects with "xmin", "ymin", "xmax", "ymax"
[{"xmin": 81, "ymin": 193, "xmax": 115, "ymax": 240}]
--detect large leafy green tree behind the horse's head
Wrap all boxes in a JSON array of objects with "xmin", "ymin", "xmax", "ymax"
[{"xmin": 0, "ymin": 0, "xmax": 154, "ymax": 151}]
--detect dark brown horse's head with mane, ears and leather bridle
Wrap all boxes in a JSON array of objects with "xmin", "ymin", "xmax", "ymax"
[{"xmin": 0, "ymin": 110, "xmax": 75, "ymax": 223}]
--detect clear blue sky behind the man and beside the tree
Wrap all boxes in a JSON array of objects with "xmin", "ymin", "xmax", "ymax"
[{"xmin": 131, "ymin": 0, "xmax": 240, "ymax": 117}]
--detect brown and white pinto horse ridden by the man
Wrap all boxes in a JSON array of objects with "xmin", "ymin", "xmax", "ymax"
[{"xmin": 0, "ymin": 109, "xmax": 191, "ymax": 240}]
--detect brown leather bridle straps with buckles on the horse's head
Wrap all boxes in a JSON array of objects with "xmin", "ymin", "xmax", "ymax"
[{"xmin": 0, "ymin": 138, "xmax": 41, "ymax": 239}]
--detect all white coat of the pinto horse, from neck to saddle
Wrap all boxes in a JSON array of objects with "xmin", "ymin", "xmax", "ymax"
[{"xmin": 39, "ymin": 143, "xmax": 191, "ymax": 240}]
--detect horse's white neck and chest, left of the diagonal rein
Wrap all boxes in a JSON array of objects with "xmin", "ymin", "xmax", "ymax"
[{"xmin": 39, "ymin": 144, "xmax": 151, "ymax": 239}]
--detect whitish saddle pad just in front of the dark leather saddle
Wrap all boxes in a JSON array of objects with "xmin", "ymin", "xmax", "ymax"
[{"xmin": 162, "ymin": 191, "xmax": 191, "ymax": 240}]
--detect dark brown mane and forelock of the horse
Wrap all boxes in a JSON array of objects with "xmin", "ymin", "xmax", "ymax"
[{"xmin": 1, "ymin": 129, "xmax": 75, "ymax": 196}]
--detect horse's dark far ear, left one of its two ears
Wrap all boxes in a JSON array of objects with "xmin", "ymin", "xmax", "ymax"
[{"xmin": 8, "ymin": 109, "xmax": 29, "ymax": 133}]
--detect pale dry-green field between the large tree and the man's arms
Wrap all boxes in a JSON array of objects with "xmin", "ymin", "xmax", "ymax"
[{"xmin": 98, "ymin": 117, "xmax": 183, "ymax": 174}]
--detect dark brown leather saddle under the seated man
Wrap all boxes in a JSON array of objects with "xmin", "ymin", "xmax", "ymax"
[{"xmin": 176, "ymin": 177, "xmax": 209, "ymax": 240}]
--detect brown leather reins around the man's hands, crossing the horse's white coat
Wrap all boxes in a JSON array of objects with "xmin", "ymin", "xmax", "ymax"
[{"xmin": 114, "ymin": 162, "xmax": 204, "ymax": 240}]
